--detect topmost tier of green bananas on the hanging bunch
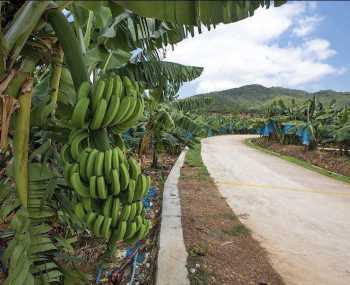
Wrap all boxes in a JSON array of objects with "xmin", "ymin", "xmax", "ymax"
[{"xmin": 71, "ymin": 75, "xmax": 145, "ymax": 133}]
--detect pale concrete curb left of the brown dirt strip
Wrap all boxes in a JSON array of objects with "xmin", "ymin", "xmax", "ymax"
[{"xmin": 156, "ymin": 149, "xmax": 190, "ymax": 285}]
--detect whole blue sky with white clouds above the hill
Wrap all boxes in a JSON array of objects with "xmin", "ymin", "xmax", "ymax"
[{"xmin": 165, "ymin": 1, "xmax": 350, "ymax": 97}]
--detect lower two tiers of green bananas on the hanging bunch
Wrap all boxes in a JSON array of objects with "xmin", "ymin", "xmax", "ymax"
[{"xmin": 61, "ymin": 139, "xmax": 151, "ymax": 242}]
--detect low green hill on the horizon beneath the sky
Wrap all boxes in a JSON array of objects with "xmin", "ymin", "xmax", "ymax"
[{"xmin": 193, "ymin": 84, "xmax": 350, "ymax": 113}]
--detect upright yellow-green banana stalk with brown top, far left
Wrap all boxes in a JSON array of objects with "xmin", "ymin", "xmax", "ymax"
[{"xmin": 14, "ymin": 77, "xmax": 33, "ymax": 208}]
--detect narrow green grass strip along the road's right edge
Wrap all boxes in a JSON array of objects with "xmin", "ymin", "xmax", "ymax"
[{"xmin": 244, "ymin": 139, "xmax": 350, "ymax": 184}]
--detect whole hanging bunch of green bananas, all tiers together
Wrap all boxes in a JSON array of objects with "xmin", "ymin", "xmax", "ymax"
[{"xmin": 61, "ymin": 76, "xmax": 151, "ymax": 243}]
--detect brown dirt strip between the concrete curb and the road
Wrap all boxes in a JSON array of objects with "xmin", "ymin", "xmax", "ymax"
[{"xmin": 178, "ymin": 146, "xmax": 284, "ymax": 285}]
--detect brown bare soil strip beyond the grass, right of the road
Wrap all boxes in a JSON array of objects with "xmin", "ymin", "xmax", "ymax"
[{"xmin": 251, "ymin": 138, "xmax": 350, "ymax": 182}]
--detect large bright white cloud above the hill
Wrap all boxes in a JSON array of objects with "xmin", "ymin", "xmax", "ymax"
[{"xmin": 166, "ymin": 2, "xmax": 344, "ymax": 96}]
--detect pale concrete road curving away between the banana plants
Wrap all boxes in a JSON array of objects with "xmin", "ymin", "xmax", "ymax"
[{"xmin": 202, "ymin": 135, "xmax": 350, "ymax": 285}]
